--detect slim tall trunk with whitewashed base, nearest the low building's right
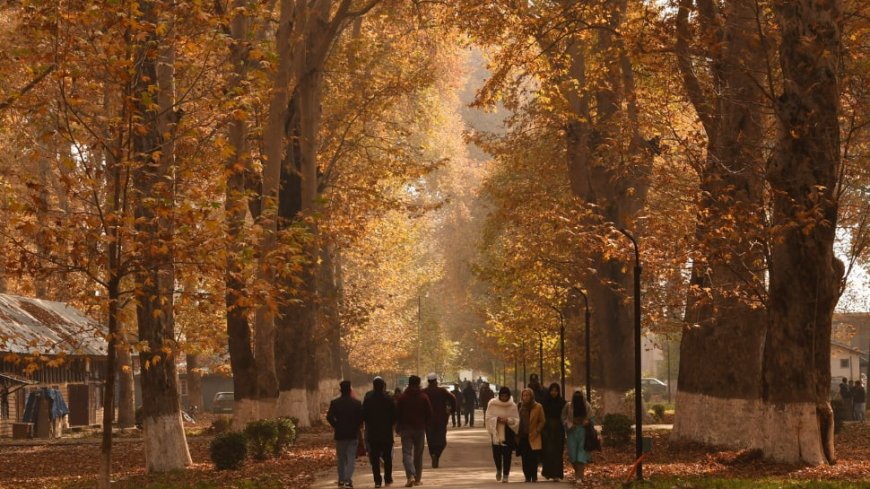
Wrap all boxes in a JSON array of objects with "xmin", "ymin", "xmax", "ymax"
[{"xmin": 132, "ymin": 1, "xmax": 192, "ymax": 472}]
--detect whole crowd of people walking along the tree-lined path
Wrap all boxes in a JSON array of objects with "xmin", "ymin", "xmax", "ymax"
[{"xmin": 326, "ymin": 373, "xmax": 594, "ymax": 488}]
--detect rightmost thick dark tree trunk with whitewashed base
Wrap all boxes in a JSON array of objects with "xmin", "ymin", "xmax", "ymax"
[{"xmin": 761, "ymin": 0, "xmax": 844, "ymax": 464}]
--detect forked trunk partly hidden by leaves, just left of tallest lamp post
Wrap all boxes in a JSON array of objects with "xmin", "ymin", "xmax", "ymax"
[{"xmin": 565, "ymin": 1, "xmax": 651, "ymax": 414}]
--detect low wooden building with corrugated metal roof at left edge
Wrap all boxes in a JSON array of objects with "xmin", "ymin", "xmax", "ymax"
[{"xmin": 0, "ymin": 294, "xmax": 108, "ymax": 436}]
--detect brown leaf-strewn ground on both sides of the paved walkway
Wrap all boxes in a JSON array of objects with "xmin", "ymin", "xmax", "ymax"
[{"xmin": 0, "ymin": 418, "xmax": 870, "ymax": 489}]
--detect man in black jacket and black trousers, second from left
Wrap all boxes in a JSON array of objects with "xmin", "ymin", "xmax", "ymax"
[{"xmin": 363, "ymin": 377, "xmax": 396, "ymax": 487}]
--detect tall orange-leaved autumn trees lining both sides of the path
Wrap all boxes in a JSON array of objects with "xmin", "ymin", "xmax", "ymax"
[{"xmin": 0, "ymin": 0, "xmax": 870, "ymax": 487}]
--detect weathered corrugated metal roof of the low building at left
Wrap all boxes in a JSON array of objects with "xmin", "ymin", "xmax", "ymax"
[{"xmin": 0, "ymin": 294, "xmax": 107, "ymax": 355}]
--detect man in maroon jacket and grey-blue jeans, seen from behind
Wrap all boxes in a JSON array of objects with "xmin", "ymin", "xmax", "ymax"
[{"xmin": 396, "ymin": 375, "xmax": 432, "ymax": 487}]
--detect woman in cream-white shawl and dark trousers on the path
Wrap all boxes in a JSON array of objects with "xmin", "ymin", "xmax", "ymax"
[{"xmin": 483, "ymin": 387, "xmax": 520, "ymax": 483}]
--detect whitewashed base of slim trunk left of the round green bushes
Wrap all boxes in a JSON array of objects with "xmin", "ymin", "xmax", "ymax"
[{"xmin": 142, "ymin": 412, "xmax": 193, "ymax": 472}]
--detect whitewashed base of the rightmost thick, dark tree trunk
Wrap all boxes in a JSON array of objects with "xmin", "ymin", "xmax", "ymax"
[{"xmin": 758, "ymin": 402, "xmax": 833, "ymax": 465}]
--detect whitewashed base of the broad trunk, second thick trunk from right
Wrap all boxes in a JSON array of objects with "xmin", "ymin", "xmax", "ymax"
[{"xmin": 671, "ymin": 390, "xmax": 764, "ymax": 449}]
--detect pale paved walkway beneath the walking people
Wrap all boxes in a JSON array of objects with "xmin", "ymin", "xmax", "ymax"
[{"xmin": 311, "ymin": 411, "xmax": 571, "ymax": 489}]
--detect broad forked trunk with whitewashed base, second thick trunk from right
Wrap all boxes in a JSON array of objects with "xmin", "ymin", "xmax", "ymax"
[{"xmin": 672, "ymin": 0, "xmax": 765, "ymax": 448}]
